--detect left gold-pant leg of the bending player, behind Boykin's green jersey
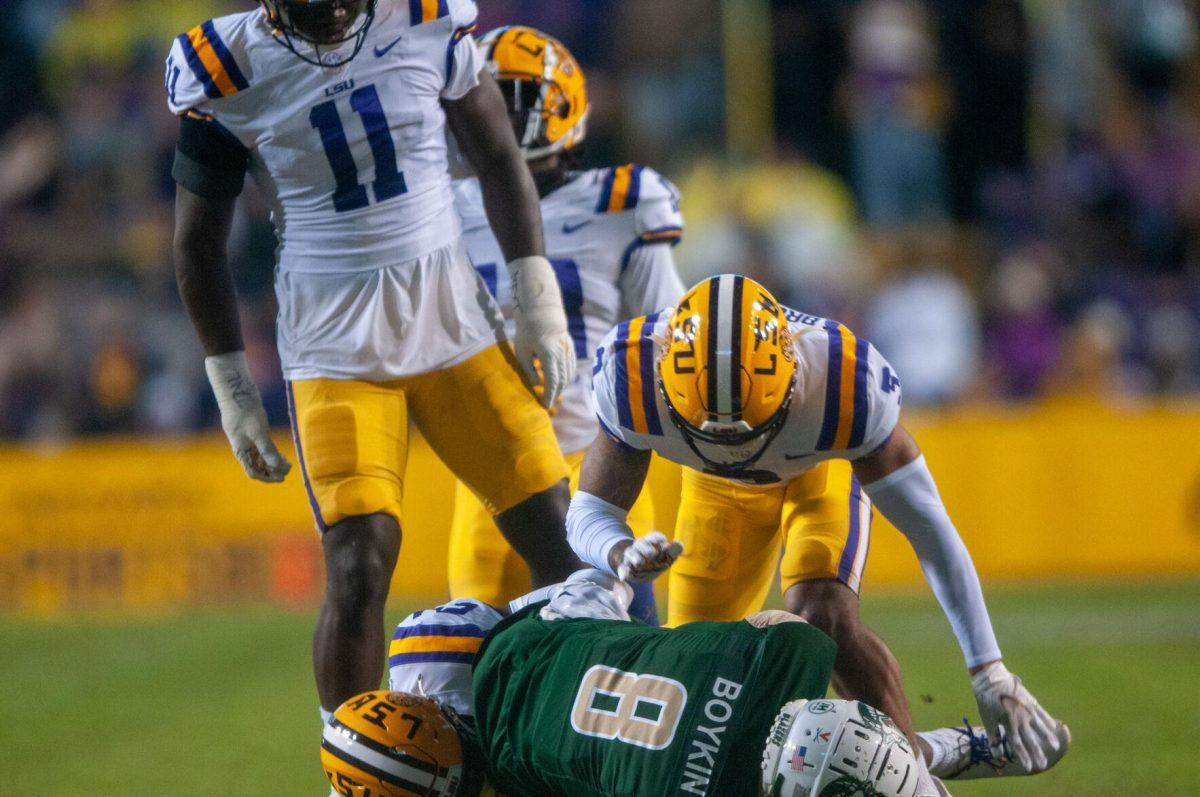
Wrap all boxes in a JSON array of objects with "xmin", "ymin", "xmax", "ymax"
[{"xmin": 667, "ymin": 469, "xmax": 784, "ymax": 625}]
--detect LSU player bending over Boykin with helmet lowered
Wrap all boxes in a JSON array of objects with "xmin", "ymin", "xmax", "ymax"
[{"xmin": 566, "ymin": 274, "xmax": 1069, "ymax": 792}]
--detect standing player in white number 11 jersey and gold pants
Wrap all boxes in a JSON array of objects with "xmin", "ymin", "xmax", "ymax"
[{"xmin": 166, "ymin": 0, "xmax": 577, "ymax": 711}]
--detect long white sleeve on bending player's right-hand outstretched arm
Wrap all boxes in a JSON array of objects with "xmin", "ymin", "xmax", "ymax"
[{"xmin": 863, "ymin": 456, "xmax": 1000, "ymax": 667}]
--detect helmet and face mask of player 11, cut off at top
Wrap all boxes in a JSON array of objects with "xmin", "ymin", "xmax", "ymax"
[{"xmin": 258, "ymin": 0, "xmax": 377, "ymax": 66}]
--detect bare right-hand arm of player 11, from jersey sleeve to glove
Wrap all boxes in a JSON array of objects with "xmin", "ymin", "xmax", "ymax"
[{"xmin": 442, "ymin": 70, "xmax": 546, "ymax": 262}]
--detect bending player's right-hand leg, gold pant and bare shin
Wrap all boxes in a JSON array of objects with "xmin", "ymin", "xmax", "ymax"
[{"xmin": 780, "ymin": 460, "xmax": 916, "ymax": 744}]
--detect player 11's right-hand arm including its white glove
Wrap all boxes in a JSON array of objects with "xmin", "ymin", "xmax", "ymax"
[{"xmin": 442, "ymin": 70, "xmax": 576, "ymax": 407}]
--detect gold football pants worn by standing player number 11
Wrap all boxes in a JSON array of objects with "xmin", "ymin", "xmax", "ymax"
[{"xmin": 288, "ymin": 346, "xmax": 568, "ymax": 531}]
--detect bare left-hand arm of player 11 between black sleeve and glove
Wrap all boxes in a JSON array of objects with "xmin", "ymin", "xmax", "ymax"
[{"xmin": 174, "ymin": 186, "xmax": 245, "ymax": 356}]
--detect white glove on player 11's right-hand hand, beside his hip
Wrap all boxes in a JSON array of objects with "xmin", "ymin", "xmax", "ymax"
[{"xmin": 509, "ymin": 256, "xmax": 576, "ymax": 407}]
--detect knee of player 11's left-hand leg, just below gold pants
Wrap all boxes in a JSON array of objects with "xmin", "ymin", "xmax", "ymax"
[{"xmin": 324, "ymin": 515, "xmax": 400, "ymax": 613}]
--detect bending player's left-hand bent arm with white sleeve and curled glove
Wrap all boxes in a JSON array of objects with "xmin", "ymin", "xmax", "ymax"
[{"xmin": 566, "ymin": 431, "xmax": 683, "ymax": 581}]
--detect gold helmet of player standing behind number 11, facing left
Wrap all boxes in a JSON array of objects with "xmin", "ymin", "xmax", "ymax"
[{"xmin": 479, "ymin": 25, "xmax": 588, "ymax": 160}]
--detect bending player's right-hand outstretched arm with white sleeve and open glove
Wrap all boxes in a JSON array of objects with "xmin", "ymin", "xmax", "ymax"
[{"xmin": 852, "ymin": 424, "xmax": 1069, "ymax": 771}]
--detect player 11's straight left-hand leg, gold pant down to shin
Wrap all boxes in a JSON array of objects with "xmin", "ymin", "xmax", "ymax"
[{"xmin": 288, "ymin": 379, "xmax": 408, "ymax": 711}]
